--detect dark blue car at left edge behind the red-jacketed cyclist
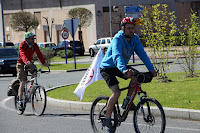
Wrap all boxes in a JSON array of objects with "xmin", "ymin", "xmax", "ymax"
[{"xmin": 0, "ymin": 48, "xmax": 18, "ymax": 76}]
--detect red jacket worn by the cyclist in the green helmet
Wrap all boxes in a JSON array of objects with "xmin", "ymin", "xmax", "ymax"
[{"xmin": 18, "ymin": 41, "xmax": 45, "ymax": 64}]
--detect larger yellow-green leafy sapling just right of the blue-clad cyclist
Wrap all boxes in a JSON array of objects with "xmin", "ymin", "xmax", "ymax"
[{"xmin": 141, "ymin": 4, "xmax": 177, "ymax": 82}]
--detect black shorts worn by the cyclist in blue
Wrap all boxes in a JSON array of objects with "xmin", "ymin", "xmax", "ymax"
[{"xmin": 100, "ymin": 66, "xmax": 138, "ymax": 88}]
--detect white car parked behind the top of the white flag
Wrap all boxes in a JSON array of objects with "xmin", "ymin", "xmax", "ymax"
[{"xmin": 89, "ymin": 37, "xmax": 112, "ymax": 57}]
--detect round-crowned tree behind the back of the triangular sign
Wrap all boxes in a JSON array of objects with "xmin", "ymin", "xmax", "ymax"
[{"xmin": 68, "ymin": 8, "xmax": 93, "ymax": 42}]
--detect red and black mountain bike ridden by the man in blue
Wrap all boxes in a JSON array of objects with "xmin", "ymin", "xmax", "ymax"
[{"xmin": 90, "ymin": 72, "xmax": 166, "ymax": 133}]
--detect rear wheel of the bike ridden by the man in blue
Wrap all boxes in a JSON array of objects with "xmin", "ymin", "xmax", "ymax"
[{"xmin": 90, "ymin": 96, "xmax": 117, "ymax": 133}]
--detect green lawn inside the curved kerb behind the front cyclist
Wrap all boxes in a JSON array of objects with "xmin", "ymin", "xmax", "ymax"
[{"xmin": 47, "ymin": 72, "xmax": 200, "ymax": 109}]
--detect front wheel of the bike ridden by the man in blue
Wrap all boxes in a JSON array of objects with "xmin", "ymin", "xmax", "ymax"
[{"xmin": 133, "ymin": 98, "xmax": 166, "ymax": 133}]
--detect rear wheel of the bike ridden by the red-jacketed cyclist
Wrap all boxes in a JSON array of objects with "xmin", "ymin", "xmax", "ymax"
[{"xmin": 14, "ymin": 93, "xmax": 26, "ymax": 115}]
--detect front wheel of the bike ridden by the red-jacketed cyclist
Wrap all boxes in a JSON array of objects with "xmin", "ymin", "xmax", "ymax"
[{"xmin": 31, "ymin": 86, "xmax": 47, "ymax": 116}]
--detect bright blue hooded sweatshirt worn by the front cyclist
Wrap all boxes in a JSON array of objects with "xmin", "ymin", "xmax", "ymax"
[{"xmin": 100, "ymin": 30, "xmax": 154, "ymax": 73}]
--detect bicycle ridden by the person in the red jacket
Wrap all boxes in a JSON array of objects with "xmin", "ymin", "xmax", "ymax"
[{"xmin": 14, "ymin": 67, "xmax": 50, "ymax": 116}]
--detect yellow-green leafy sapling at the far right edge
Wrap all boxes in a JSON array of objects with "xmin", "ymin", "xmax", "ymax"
[{"xmin": 179, "ymin": 11, "xmax": 200, "ymax": 77}]
